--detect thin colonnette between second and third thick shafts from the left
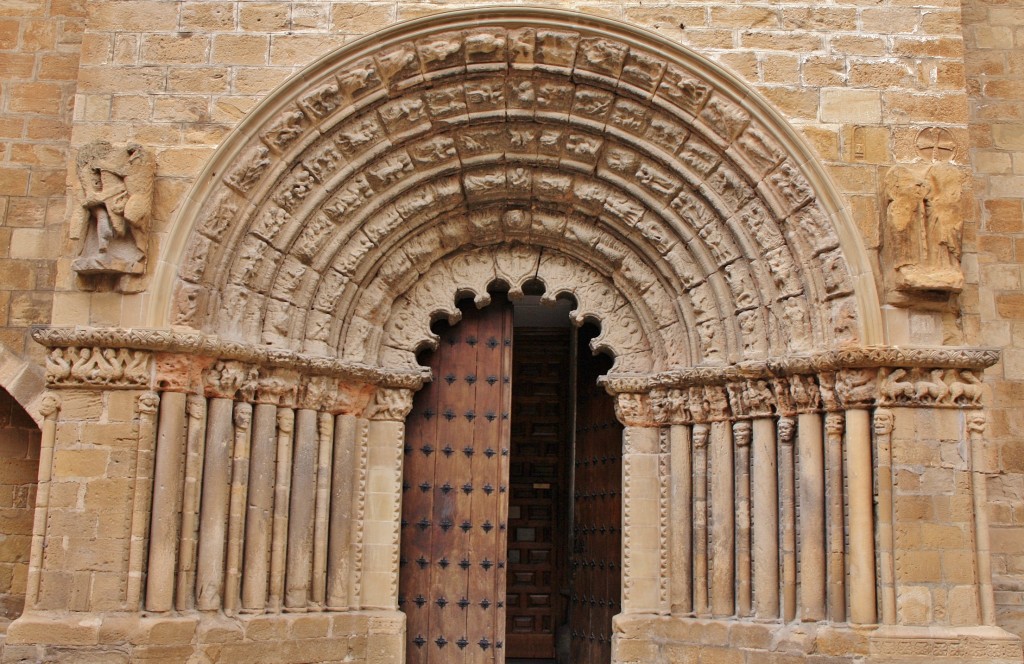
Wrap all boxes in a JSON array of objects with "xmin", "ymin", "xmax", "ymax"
[{"xmin": 224, "ymin": 403, "xmax": 253, "ymax": 615}]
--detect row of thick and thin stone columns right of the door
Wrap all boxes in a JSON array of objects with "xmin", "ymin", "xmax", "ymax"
[{"xmin": 618, "ymin": 376, "xmax": 880, "ymax": 624}]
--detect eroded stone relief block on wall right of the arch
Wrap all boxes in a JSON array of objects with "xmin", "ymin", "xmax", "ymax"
[{"xmin": 884, "ymin": 163, "xmax": 964, "ymax": 293}]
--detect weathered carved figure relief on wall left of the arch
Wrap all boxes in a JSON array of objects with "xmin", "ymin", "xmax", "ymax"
[{"xmin": 72, "ymin": 141, "xmax": 155, "ymax": 275}]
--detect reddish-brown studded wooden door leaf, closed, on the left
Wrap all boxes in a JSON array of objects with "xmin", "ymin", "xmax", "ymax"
[{"xmin": 398, "ymin": 302, "xmax": 512, "ymax": 664}]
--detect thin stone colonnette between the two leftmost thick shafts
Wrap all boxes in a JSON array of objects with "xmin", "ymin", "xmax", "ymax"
[{"xmin": 174, "ymin": 395, "xmax": 206, "ymax": 611}]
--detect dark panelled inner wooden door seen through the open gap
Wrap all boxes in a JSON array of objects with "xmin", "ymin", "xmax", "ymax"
[{"xmin": 505, "ymin": 328, "xmax": 571, "ymax": 659}]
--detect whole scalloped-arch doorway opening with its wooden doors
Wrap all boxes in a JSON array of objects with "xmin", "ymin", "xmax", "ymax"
[{"xmin": 398, "ymin": 296, "xmax": 622, "ymax": 664}]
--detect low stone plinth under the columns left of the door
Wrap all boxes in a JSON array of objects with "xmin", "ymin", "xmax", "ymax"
[{"xmin": 0, "ymin": 611, "xmax": 406, "ymax": 664}]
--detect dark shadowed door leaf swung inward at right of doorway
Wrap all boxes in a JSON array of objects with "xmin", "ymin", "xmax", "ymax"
[{"xmin": 569, "ymin": 350, "xmax": 623, "ymax": 664}]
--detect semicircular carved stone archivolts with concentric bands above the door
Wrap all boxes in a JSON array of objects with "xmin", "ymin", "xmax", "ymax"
[{"xmin": 157, "ymin": 10, "xmax": 879, "ymax": 371}]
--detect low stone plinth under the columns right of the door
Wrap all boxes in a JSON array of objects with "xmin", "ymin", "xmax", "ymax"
[{"xmin": 612, "ymin": 615, "xmax": 1022, "ymax": 664}]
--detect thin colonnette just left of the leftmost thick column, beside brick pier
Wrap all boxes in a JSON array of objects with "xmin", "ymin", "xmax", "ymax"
[{"xmin": 125, "ymin": 392, "xmax": 160, "ymax": 609}]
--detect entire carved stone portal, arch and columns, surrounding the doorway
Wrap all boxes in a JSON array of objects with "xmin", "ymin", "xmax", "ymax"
[{"xmin": 22, "ymin": 10, "xmax": 1020, "ymax": 662}]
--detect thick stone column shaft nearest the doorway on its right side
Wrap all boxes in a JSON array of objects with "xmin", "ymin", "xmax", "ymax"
[{"xmin": 669, "ymin": 424, "xmax": 693, "ymax": 614}]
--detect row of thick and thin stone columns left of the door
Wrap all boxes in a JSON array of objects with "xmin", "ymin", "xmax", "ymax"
[{"xmin": 139, "ymin": 370, "xmax": 412, "ymax": 615}]
